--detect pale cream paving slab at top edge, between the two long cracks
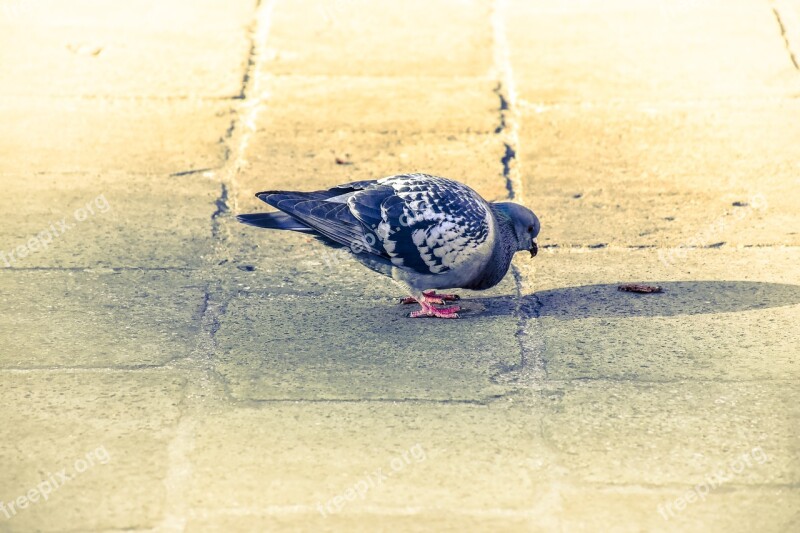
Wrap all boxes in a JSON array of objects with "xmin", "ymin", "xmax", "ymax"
[{"xmin": 266, "ymin": 0, "xmax": 492, "ymax": 78}]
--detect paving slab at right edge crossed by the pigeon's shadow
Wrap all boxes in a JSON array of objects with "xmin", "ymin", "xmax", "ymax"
[{"xmin": 518, "ymin": 248, "xmax": 800, "ymax": 382}]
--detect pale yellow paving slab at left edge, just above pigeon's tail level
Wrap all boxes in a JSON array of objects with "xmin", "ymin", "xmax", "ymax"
[{"xmin": 0, "ymin": 96, "xmax": 233, "ymax": 175}]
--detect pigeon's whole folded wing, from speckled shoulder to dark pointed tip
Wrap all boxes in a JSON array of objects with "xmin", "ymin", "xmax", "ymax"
[{"xmin": 243, "ymin": 174, "xmax": 494, "ymax": 275}]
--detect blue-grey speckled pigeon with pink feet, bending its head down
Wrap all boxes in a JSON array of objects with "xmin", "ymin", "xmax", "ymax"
[{"xmin": 237, "ymin": 174, "xmax": 540, "ymax": 318}]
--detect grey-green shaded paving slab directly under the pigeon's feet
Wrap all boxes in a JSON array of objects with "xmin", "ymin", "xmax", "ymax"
[{"xmin": 214, "ymin": 288, "xmax": 519, "ymax": 401}]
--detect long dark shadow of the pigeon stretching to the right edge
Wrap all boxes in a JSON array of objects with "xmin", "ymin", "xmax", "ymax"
[{"xmin": 465, "ymin": 281, "xmax": 800, "ymax": 320}]
